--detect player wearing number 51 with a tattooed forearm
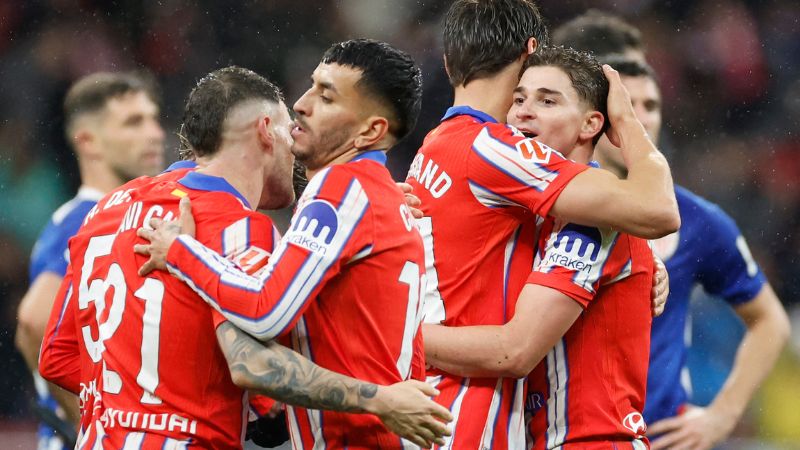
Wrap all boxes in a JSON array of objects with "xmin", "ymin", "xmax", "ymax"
[{"xmin": 41, "ymin": 67, "xmax": 447, "ymax": 448}]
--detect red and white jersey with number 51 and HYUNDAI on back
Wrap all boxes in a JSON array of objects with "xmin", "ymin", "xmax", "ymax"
[{"xmin": 41, "ymin": 172, "xmax": 277, "ymax": 449}]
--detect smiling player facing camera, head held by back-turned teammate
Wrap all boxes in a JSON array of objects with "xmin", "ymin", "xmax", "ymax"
[{"xmin": 424, "ymin": 47, "xmax": 653, "ymax": 449}]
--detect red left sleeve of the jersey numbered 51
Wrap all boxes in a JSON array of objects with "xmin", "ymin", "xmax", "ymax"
[{"xmin": 39, "ymin": 266, "xmax": 81, "ymax": 395}]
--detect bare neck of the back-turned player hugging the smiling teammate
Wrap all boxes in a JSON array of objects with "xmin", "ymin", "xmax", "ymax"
[{"xmin": 453, "ymin": 66, "xmax": 519, "ymax": 123}]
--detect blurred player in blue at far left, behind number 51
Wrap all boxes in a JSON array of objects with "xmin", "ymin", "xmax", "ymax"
[{"xmin": 16, "ymin": 73, "xmax": 164, "ymax": 450}]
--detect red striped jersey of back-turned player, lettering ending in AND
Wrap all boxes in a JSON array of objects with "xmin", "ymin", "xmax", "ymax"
[{"xmin": 407, "ymin": 107, "xmax": 586, "ymax": 450}]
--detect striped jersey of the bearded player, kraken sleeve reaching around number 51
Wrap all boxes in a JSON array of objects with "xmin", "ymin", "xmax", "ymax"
[{"xmin": 162, "ymin": 151, "xmax": 425, "ymax": 449}]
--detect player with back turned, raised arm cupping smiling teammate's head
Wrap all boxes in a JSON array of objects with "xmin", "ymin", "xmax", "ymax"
[{"xmin": 409, "ymin": 0, "xmax": 680, "ymax": 449}]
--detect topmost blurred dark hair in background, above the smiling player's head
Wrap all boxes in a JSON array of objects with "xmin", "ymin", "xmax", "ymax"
[{"xmin": 553, "ymin": 9, "xmax": 644, "ymax": 56}]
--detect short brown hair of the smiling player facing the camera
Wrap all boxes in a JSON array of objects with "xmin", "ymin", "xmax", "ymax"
[{"xmin": 523, "ymin": 46, "xmax": 610, "ymax": 144}]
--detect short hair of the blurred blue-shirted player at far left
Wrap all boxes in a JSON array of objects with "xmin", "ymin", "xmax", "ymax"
[{"xmin": 64, "ymin": 72, "xmax": 159, "ymax": 136}]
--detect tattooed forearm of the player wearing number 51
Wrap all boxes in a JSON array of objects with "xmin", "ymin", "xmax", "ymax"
[{"xmin": 217, "ymin": 322, "xmax": 378, "ymax": 412}]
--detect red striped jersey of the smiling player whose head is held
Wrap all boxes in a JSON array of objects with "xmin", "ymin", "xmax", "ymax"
[{"xmin": 526, "ymin": 219, "xmax": 653, "ymax": 450}]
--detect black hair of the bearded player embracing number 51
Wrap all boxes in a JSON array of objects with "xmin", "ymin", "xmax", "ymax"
[{"xmin": 322, "ymin": 39, "xmax": 422, "ymax": 141}]
